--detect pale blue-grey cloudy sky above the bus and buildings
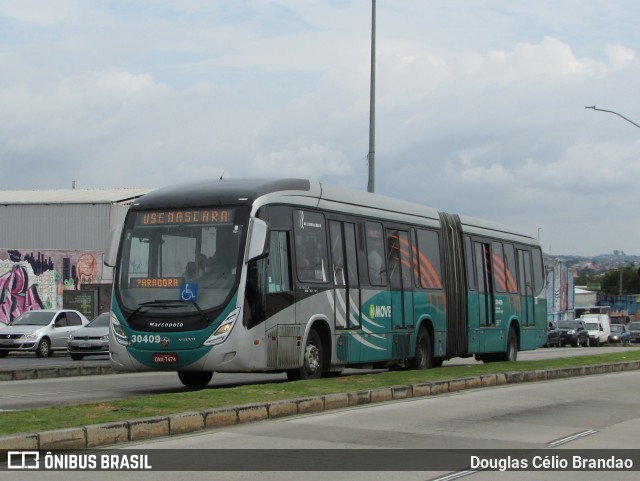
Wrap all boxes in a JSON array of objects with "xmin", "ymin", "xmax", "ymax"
[{"xmin": 0, "ymin": 0, "xmax": 640, "ymax": 255}]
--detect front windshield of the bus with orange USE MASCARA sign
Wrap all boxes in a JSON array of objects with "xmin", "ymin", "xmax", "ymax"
[{"xmin": 116, "ymin": 207, "xmax": 247, "ymax": 315}]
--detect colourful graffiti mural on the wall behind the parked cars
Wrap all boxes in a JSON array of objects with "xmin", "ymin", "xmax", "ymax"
[{"xmin": 0, "ymin": 249, "xmax": 104, "ymax": 324}]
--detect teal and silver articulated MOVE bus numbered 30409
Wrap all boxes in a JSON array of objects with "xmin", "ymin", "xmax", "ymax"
[{"xmin": 105, "ymin": 179, "xmax": 547, "ymax": 387}]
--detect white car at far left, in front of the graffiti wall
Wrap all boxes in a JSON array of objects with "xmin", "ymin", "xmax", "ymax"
[{"xmin": 0, "ymin": 309, "xmax": 89, "ymax": 357}]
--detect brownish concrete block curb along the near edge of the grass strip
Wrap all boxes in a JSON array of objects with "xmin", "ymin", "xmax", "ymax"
[{"xmin": 0, "ymin": 361, "xmax": 640, "ymax": 452}]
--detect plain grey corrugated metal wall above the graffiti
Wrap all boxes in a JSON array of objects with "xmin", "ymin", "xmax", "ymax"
[{"xmin": 0, "ymin": 204, "xmax": 114, "ymax": 251}]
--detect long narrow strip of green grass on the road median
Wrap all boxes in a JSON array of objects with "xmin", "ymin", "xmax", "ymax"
[{"xmin": 0, "ymin": 349, "xmax": 640, "ymax": 435}]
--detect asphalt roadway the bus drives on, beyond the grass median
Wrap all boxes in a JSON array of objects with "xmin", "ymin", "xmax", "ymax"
[{"xmin": 0, "ymin": 347, "xmax": 638, "ymax": 411}]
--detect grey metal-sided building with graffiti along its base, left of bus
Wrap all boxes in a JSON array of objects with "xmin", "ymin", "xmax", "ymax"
[{"xmin": 0, "ymin": 189, "xmax": 151, "ymax": 323}]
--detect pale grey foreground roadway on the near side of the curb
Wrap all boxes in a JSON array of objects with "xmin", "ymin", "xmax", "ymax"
[{"xmin": 3, "ymin": 371, "xmax": 640, "ymax": 481}]
